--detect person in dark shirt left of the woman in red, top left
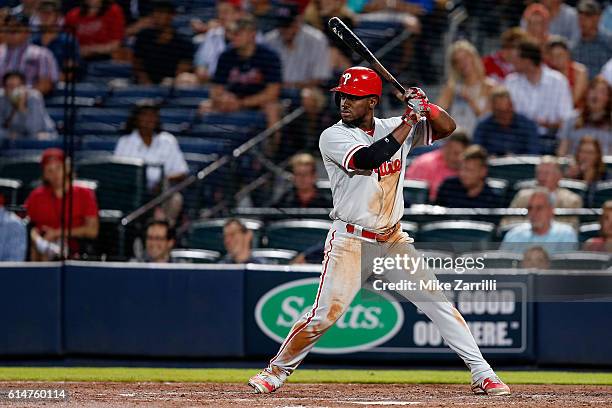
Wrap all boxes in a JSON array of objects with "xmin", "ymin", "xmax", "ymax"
[{"xmin": 32, "ymin": 0, "xmax": 80, "ymax": 81}]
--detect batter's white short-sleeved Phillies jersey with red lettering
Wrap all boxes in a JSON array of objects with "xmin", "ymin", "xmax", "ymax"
[{"xmin": 319, "ymin": 117, "xmax": 432, "ymax": 233}]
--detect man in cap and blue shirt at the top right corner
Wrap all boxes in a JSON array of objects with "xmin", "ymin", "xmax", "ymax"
[{"xmin": 572, "ymin": 0, "xmax": 612, "ymax": 79}]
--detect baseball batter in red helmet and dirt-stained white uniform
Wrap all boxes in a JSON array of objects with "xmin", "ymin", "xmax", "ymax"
[{"xmin": 248, "ymin": 67, "xmax": 510, "ymax": 395}]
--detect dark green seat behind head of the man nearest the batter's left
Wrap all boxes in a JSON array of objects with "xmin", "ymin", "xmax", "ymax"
[{"xmin": 184, "ymin": 218, "xmax": 263, "ymax": 253}]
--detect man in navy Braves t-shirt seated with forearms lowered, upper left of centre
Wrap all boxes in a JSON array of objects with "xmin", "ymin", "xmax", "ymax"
[{"xmin": 200, "ymin": 16, "xmax": 282, "ymax": 144}]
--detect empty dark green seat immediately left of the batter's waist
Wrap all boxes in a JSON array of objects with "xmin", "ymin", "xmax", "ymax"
[{"xmin": 264, "ymin": 219, "xmax": 331, "ymax": 252}]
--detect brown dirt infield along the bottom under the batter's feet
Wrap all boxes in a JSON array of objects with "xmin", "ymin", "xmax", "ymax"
[{"xmin": 0, "ymin": 382, "xmax": 612, "ymax": 408}]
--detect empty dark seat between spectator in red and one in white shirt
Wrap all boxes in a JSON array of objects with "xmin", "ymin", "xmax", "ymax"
[{"xmin": 76, "ymin": 156, "xmax": 146, "ymax": 214}]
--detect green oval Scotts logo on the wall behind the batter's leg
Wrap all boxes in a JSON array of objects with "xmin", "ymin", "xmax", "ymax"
[{"xmin": 255, "ymin": 278, "xmax": 404, "ymax": 354}]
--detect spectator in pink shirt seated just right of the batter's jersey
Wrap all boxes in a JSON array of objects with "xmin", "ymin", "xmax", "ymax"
[{"xmin": 406, "ymin": 129, "xmax": 470, "ymax": 203}]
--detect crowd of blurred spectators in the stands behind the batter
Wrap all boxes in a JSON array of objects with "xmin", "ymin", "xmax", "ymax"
[{"xmin": 0, "ymin": 0, "xmax": 612, "ymax": 262}]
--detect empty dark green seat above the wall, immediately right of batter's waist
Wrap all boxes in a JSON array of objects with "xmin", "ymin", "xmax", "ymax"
[{"xmin": 418, "ymin": 221, "xmax": 495, "ymax": 249}]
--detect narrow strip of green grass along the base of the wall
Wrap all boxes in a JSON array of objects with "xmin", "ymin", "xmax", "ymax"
[{"xmin": 0, "ymin": 367, "xmax": 612, "ymax": 385}]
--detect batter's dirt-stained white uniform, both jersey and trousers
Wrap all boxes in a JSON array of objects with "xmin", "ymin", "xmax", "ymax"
[{"xmin": 270, "ymin": 117, "xmax": 494, "ymax": 381}]
